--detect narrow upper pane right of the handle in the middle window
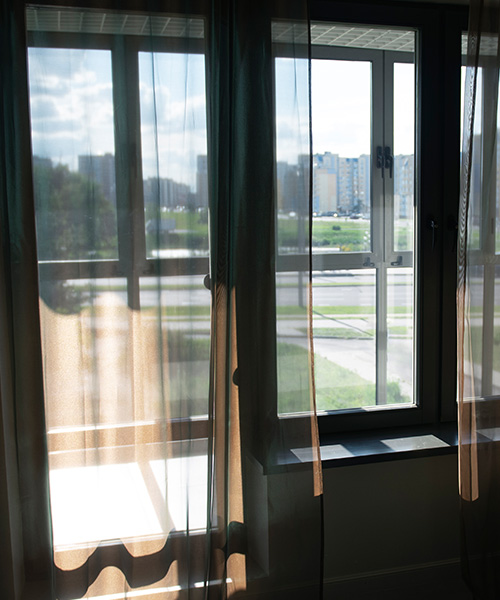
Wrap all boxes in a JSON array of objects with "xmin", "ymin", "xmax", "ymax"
[{"xmin": 394, "ymin": 63, "xmax": 415, "ymax": 252}]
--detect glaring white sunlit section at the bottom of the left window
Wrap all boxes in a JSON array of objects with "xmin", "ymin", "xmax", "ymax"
[{"xmin": 50, "ymin": 439, "xmax": 208, "ymax": 548}]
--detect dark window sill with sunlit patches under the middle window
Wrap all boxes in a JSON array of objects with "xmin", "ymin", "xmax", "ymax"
[{"xmin": 275, "ymin": 423, "xmax": 458, "ymax": 470}]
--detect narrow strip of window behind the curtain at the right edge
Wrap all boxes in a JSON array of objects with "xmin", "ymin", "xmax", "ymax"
[{"xmin": 462, "ymin": 34, "xmax": 500, "ymax": 404}]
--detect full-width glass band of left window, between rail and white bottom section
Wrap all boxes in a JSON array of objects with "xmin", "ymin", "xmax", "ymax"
[{"xmin": 40, "ymin": 275, "xmax": 210, "ymax": 430}]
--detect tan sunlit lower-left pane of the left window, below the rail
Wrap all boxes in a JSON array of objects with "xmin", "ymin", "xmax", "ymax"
[{"xmin": 40, "ymin": 279, "xmax": 134, "ymax": 432}]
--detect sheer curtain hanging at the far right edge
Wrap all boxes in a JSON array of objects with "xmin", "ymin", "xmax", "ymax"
[{"xmin": 458, "ymin": 0, "xmax": 500, "ymax": 599}]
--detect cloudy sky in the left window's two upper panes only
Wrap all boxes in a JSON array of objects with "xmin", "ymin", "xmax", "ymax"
[{"xmin": 29, "ymin": 49, "xmax": 207, "ymax": 188}]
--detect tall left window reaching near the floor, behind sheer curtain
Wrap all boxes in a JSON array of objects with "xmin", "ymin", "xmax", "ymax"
[{"xmin": 27, "ymin": 8, "xmax": 210, "ymax": 569}]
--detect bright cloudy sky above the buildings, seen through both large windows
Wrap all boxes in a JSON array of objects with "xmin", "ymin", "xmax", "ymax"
[{"xmin": 29, "ymin": 48, "xmax": 414, "ymax": 190}]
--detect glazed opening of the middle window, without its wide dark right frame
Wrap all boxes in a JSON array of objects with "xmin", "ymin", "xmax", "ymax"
[{"xmin": 275, "ymin": 22, "xmax": 426, "ymax": 432}]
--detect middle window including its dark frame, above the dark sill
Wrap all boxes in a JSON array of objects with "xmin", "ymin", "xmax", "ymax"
[{"xmin": 274, "ymin": 6, "xmax": 463, "ymax": 433}]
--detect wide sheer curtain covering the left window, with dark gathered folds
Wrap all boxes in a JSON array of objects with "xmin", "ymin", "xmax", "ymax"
[{"xmin": 0, "ymin": 0, "xmax": 322, "ymax": 600}]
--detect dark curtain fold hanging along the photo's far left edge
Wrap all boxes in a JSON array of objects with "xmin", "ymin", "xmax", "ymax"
[{"xmin": 0, "ymin": 1, "xmax": 52, "ymax": 598}]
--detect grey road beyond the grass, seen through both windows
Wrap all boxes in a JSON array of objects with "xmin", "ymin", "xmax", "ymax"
[{"xmin": 63, "ymin": 271, "xmax": 413, "ymax": 406}]
